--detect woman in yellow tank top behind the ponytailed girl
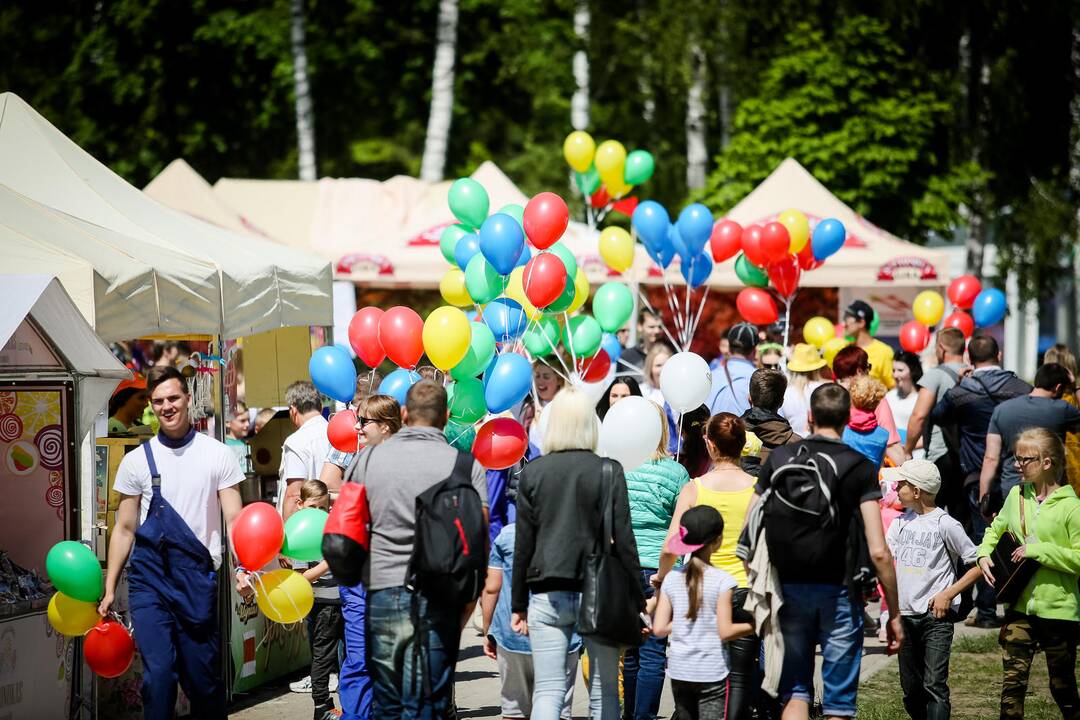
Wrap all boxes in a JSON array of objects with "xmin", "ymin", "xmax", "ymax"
[{"xmin": 652, "ymin": 412, "xmax": 761, "ymax": 720}]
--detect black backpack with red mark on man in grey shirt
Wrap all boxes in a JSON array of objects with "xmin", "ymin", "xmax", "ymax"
[{"xmin": 406, "ymin": 452, "xmax": 487, "ymax": 607}]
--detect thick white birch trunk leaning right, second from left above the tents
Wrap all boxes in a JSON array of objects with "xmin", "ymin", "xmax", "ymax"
[{"xmin": 420, "ymin": 0, "xmax": 458, "ymax": 182}]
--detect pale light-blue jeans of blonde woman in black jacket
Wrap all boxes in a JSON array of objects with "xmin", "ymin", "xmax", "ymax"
[{"xmin": 528, "ymin": 590, "xmax": 619, "ymax": 720}]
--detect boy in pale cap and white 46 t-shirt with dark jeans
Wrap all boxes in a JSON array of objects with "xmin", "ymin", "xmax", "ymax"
[{"xmin": 885, "ymin": 460, "xmax": 981, "ymax": 718}]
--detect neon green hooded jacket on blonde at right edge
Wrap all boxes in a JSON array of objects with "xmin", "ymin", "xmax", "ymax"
[{"xmin": 978, "ymin": 483, "xmax": 1080, "ymax": 621}]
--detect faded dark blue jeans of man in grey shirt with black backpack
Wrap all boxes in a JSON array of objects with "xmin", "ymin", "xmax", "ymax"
[{"xmin": 367, "ymin": 586, "xmax": 460, "ymax": 720}]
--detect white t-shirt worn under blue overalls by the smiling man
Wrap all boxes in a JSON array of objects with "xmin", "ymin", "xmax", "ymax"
[{"xmin": 112, "ymin": 433, "xmax": 244, "ymax": 568}]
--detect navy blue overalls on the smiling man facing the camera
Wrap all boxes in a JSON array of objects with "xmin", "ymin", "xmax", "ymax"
[{"xmin": 127, "ymin": 443, "xmax": 226, "ymax": 720}]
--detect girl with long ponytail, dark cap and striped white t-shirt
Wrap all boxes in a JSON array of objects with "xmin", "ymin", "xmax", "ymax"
[{"xmin": 652, "ymin": 505, "xmax": 754, "ymax": 720}]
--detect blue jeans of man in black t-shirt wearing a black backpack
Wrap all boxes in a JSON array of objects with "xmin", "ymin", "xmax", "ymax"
[{"xmin": 780, "ymin": 583, "xmax": 863, "ymax": 717}]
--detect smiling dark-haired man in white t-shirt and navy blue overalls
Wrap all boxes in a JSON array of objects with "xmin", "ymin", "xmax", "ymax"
[{"xmin": 98, "ymin": 366, "xmax": 252, "ymax": 720}]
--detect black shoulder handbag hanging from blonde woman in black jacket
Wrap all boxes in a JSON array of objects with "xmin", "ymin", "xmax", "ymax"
[{"xmin": 578, "ymin": 460, "xmax": 645, "ymax": 648}]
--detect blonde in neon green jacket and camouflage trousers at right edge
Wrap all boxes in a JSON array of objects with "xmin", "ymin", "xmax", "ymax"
[{"xmin": 978, "ymin": 427, "xmax": 1080, "ymax": 718}]
